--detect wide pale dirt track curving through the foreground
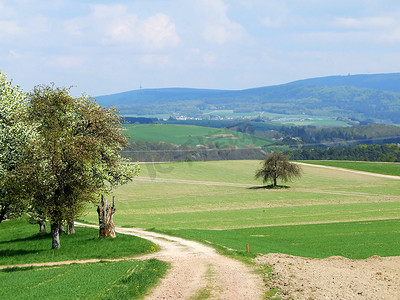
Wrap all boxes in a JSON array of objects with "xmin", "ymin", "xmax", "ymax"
[{"xmin": 79, "ymin": 224, "xmax": 263, "ymax": 300}]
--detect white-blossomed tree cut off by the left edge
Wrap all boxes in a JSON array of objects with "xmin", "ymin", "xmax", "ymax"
[{"xmin": 0, "ymin": 72, "xmax": 34, "ymax": 222}]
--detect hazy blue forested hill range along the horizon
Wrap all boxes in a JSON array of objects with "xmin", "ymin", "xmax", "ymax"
[{"xmin": 97, "ymin": 73, "xmax": 400, "ymax": 124}]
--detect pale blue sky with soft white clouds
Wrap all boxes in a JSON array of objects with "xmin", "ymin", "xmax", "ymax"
[{"xmin": 0, "ymin": 0, "xmax": 400, "ymax": 96}]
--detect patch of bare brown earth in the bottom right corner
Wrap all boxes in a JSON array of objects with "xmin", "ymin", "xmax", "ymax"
[{"xmin": 256, "ymin": 253, "xmax": 400, "ymax": 300}]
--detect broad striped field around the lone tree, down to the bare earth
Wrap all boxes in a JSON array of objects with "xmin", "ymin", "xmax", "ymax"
[{"xmin": 79, "ymin": 161, "xmax": 400, "ymax": 258}]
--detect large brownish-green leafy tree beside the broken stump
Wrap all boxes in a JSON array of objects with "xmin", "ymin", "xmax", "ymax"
[{"xmin": 28, "ymin": 85, "xmax": 138, "ymax": 248}]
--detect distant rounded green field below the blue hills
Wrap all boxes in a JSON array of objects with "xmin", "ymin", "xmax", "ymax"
[{"xmin": 124, "ymin": 124, "xmax": 272, "ymax": 148}]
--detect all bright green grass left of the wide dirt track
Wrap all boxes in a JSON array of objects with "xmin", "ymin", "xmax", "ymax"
[{"xmin": 0, "ymin": 219, "xmax": 168, "ymax": 299}]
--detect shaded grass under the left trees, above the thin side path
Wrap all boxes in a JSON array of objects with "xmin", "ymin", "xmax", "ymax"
[{"xmin": 0, "ymin": 219, "xmax": 157, "ymax": 265}]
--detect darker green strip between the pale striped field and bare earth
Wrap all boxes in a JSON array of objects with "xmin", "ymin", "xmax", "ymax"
[{"xmin": 155, "ymin": 219, "xmax": 400, "ymax": 261}]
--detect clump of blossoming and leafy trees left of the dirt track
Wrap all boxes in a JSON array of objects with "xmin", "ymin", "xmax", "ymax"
[{"xmin": 0, "ymin": 73, "xmax": 139, "ymax": 248}]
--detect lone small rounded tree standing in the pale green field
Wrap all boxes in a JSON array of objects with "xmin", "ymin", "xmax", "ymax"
[{"xmin": 255, "ymin": 152, "xmax": 302, "ymax": 187}]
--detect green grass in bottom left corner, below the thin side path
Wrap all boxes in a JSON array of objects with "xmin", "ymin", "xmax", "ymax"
[{"xmin": 0, "ymin": 259, "xmax": 168, "ymax": 299}]
